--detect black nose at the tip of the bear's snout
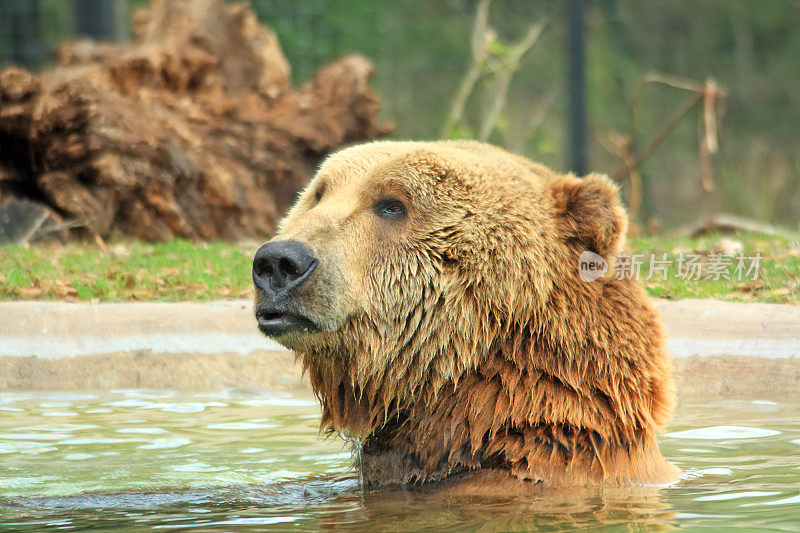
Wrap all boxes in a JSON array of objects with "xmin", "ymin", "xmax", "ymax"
[{"xmin": 253, "ymin": 241, "xmax": 318, "ymax": 296}]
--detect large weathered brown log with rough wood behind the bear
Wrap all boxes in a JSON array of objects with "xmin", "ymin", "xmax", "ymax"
[{"xmin": 0, "ymin": 0, "xmax": 390, "ymax": 240}]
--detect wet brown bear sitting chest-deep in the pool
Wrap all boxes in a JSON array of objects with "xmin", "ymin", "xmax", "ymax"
[{"xmin": 253, "ymin": 141, "xmax": 678, "ymax": 487}]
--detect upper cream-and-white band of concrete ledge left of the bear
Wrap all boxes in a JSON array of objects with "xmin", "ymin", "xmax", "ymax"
[{"xmin": 0, "ymin": 300, "xmax": 284, "ymax": 359}]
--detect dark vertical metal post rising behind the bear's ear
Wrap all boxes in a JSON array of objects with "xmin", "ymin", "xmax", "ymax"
[{"xmin": 567, "ymin": 0, "xmax": 587, "ymax": 176}]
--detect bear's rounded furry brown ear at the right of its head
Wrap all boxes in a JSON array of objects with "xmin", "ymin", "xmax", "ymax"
[{"xmin": 551, "ymin": 174, "xmax": 628, "ymax": 263}]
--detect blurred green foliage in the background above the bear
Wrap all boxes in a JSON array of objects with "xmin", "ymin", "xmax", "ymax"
[{"xmin": 5, "ymin": 0, "xmax": 800, "ymax": 229}]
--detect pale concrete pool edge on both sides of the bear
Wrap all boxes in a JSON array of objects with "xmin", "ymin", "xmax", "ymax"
[{"xmin": 0, "ymin": 300, "xmax": 800, "ymax": 398}]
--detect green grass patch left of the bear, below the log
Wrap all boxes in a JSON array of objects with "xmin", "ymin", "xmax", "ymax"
[{"xmin": 0, "ymin": 240, "xmax": 258, "ymax": 301}]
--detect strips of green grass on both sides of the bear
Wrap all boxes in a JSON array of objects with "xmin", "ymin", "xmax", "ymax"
[{"xmin": 0, "ymin": 234, "xmax": 800, "ymax": 304}]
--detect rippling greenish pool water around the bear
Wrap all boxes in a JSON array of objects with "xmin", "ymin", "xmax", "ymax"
[{"xmin": 0, "ymin": 390, "xmax": 800, "ymax": 531}]
